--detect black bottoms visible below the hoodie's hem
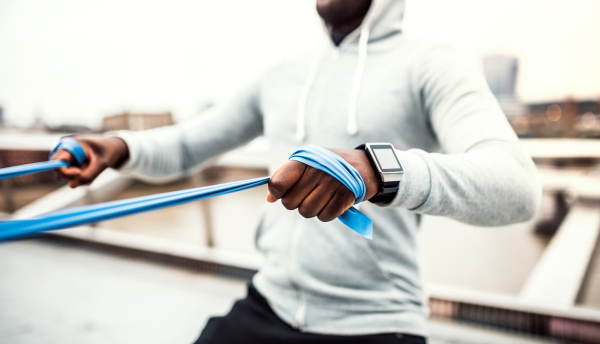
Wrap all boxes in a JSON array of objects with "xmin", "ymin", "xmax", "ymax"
[{"xmin": 196, "ymin": 284, "xmax": 427, "ymax": 344}]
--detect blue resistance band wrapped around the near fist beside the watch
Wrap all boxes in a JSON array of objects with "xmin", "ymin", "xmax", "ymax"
[{"xmin": 0, "ymin": 142, "xmax": 373, "ymax": 241}]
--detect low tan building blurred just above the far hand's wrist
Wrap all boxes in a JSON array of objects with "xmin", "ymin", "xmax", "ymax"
[{"xmin": 102, "ymin": 112, "xmax": 175, "ymax": 131}]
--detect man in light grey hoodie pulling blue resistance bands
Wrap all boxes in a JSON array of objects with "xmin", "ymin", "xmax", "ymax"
[{"xmin": 54, "ymin": 0, "xmax": 540, "ymax": 343}]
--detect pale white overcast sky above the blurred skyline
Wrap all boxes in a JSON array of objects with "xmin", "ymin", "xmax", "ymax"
[{"xmin": 0, "ymin": 0, "xmax": 600, "ymax": 126}]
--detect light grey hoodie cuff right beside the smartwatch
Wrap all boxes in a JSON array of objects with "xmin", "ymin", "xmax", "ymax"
[{"xmin": 378, "ymin": 149, "xmax": 431, "ymax": 210}]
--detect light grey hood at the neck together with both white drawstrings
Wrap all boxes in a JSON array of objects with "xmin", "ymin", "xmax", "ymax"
[{"xmin": 296, "ymin": 0, "xmax": 405, "ymax": 143}]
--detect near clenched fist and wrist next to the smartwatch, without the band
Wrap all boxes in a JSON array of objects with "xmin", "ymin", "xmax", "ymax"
[{"xmin": 267, "ymin": 149, "xmax": 379, "ymax": 222}]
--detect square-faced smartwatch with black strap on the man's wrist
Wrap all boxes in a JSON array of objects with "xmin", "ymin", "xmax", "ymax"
[{"xmin": 356, "ymin": 143, "xmax": 404, "ymax": 203}]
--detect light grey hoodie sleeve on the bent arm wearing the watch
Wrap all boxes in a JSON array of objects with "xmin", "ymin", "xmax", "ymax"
[{"xmin": 390, "ymin": 47, "xmax": 541, "ymax": 226}]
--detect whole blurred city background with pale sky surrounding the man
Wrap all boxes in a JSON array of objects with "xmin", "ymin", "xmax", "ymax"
[{"xmin": 0, "ymin": 0, "xmax": 600, "ymax": 343}]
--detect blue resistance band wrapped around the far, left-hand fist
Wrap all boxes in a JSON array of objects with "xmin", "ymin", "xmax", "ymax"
[{"xmin": 0, "ymin": 137, "xmax": 85, "ymax": 179}]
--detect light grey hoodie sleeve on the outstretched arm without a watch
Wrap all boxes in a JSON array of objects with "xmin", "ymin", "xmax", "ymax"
[{"xmin": 111, "ymin": 76, "xmax": 263, "ymax": 182}]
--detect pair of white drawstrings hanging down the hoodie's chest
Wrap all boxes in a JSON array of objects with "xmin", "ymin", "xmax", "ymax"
[{"xmin": 296, "ymin": 25, "xmax": 370, "ymax": 143}]
